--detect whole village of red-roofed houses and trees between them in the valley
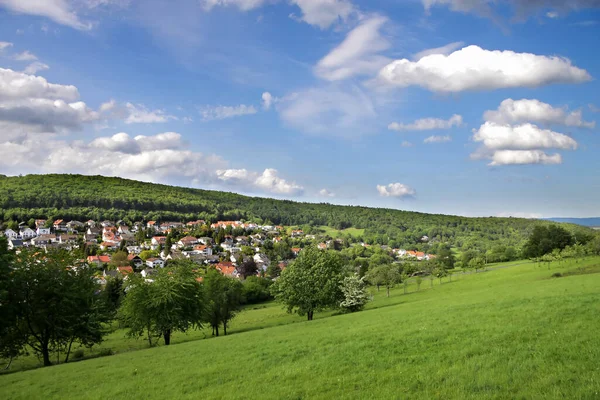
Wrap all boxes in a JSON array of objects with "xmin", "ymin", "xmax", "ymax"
[{"xmin": 1, "ymin": 219, "xmax": 435, "ymax": 284}]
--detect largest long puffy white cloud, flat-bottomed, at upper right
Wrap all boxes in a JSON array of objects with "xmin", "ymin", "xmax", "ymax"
[{"xmin": 379, "ymin": 46, "xmax": 591, "ymax": 92}]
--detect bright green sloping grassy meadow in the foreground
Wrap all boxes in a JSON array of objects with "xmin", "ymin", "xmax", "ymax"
[{"xmin": 0, "ymin": 258, "xmax": 600, "ymax": 399}]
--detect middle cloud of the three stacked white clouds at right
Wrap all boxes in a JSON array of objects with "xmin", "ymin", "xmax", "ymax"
[{"xmin": 473, "ymin": 121, "xmax": 577, "ymax": 150}]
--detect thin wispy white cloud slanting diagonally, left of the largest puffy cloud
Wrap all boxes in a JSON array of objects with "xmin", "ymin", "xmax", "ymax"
[{"xmin": 315, "ymin": 16, "xmax": 390, "ymax": 81}]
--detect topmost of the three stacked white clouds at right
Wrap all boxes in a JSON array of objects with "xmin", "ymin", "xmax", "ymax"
[{"xmin": 484, "ymin": 99, "xmax": 596, "ymax": 128}]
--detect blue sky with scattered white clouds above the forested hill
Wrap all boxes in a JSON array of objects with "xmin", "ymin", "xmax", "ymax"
[{"xmin": 0, "ymin": 0, "xmax": 600, "ymax": 217}]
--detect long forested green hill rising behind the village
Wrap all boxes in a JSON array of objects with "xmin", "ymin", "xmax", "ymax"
[{"xmin": 0, "ymin": 175, "xmax": 588, "ymax": 248}]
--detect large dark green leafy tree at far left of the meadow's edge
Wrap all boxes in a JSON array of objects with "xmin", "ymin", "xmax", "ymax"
[{"xmin": 8, "ymin": 252, "xmax": 110, "ymax": 365}]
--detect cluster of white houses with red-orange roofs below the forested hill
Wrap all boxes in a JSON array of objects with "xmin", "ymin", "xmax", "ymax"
[{"xmin": 0, "ymin": 219, "xmax": 435, "ymax": 282}]
